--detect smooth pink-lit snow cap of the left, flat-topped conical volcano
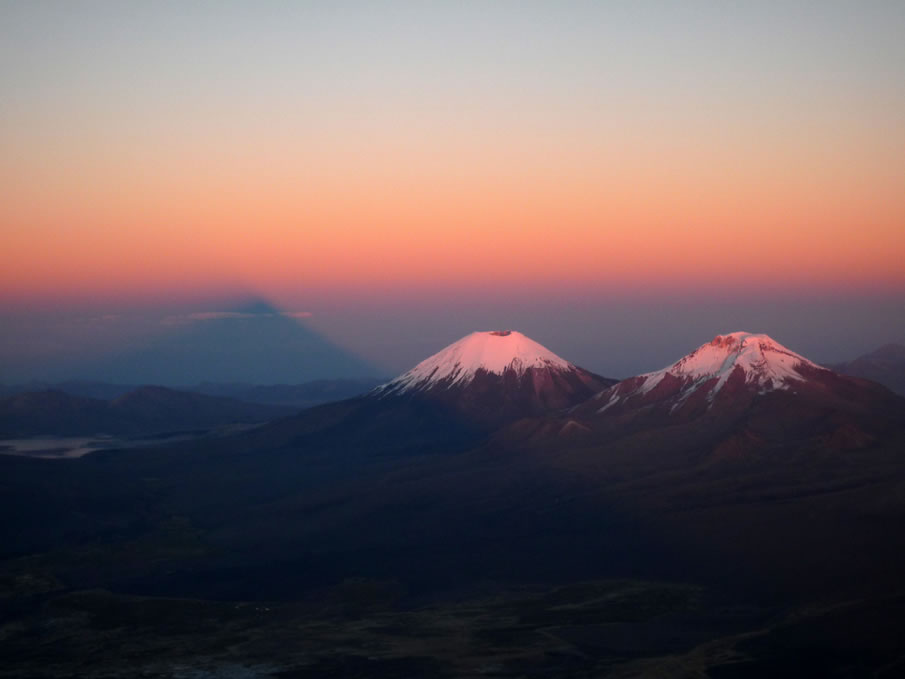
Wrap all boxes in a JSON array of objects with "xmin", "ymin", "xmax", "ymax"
[{"xmin": 375, "ymin": 330, "xmax": 576, "ymax": 395}]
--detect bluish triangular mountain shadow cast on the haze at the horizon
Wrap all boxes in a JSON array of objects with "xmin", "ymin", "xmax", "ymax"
[{"xmin": 85, "ymin": 300, "xmax": 379, "ymax": 386}]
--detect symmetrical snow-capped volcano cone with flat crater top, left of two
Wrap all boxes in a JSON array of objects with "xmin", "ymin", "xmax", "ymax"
[{"xmin": 371, "ymin": 330, "xmax": 615, "ymax": 420}]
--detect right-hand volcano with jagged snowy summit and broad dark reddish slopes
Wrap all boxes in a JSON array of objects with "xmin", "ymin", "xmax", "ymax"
[{"xmin": 537, "ymin": 333, "xmax": 905, "ymax": 456}]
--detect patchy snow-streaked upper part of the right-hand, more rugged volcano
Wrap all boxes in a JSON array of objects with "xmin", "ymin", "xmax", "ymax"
[{"xmin": 598, "ymin": 332, "xmax": 830, "ymax": 413}]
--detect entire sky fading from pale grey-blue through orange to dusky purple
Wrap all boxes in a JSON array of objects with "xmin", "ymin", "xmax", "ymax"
[{"xmin": 0, "ymin": 0, "xmax": 905, "ymax": 381}]
